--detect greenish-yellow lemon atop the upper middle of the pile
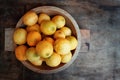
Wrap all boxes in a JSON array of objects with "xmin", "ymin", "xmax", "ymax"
[{"xmin": 40, "ymin": 21, "xmax": 56, "ymax": 35}]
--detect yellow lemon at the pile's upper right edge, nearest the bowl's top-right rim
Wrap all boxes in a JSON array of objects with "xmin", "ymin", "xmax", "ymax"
[{"xmin": 52, "ymin": 15, "xmax": 65, "ymax": 28}]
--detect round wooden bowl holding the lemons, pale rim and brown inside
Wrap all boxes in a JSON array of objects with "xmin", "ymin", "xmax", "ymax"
[{"xmin": 16, "ymin": 6, "xmax": 81, "ymax": 74}]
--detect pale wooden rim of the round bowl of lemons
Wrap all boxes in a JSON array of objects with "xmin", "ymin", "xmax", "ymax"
[{"xmin": 16, "ymin": 6, "xmax": 81, "ymax": 74}]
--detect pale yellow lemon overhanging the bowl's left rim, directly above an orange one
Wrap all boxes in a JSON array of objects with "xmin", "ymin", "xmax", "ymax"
[{"xmin": 13, "ymin": 28, "xmax": 27, "ymax": 45}]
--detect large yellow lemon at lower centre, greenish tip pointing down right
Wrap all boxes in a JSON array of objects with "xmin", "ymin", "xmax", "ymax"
[{"xmin": 36, "ymin": 40, "xmax": 53, "ymax": 58}]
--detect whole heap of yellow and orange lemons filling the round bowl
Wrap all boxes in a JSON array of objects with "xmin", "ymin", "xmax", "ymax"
[{"xmin": 13, "ymin": 11, "xmax": 78, "ymax": 67}]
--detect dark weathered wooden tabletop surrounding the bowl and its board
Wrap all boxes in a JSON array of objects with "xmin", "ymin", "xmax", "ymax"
[{"xmin": 0, "ymin": 0, "xmax": 120, "ymax": 80}]
